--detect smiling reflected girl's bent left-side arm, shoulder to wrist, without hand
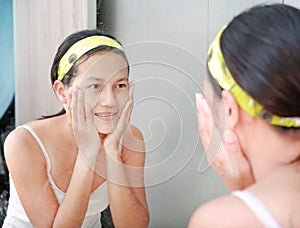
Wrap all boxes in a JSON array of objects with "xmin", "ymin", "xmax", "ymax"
[{"xmin": 5, "ymin": 129, "xmax": 93, "ymax": 227}]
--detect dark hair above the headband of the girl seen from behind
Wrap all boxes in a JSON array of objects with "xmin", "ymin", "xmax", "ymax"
[{"xmin": 210, "ymin": 4, "xmax": 300, "ymax": 126}]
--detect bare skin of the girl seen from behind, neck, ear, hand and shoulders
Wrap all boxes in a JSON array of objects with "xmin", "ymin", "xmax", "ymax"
[{"xmin": 188, "ymin": 76, "xmax": 300, "ymax": 228}]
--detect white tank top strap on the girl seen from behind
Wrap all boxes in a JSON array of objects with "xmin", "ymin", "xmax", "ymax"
[{"xmin": 231, "ymin": 190, "xmax": 281, "ymax": 228}]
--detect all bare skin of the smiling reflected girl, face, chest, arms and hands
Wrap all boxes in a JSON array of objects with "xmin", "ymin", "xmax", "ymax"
[{"xmin": 4, "ymin": 52, "xmax": 149, "ymax": 227}]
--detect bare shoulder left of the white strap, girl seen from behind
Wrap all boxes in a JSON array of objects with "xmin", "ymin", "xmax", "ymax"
[{"xmin": 188, "ymin": 195, "xmax": 260, "ymax": 228}]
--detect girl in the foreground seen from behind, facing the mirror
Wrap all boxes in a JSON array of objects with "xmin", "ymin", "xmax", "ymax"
[{"xmin": 189, "ymin": 4, "xmax": 300, "ymax": 228}]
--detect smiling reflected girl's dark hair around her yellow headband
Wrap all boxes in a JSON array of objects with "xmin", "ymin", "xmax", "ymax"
[{"xmin": 41, "ymin": 29, "xmax": 129, "ymax": 119}]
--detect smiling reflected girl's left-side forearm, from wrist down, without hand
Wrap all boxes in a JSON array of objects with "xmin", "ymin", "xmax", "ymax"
[{"xmin": 53, "ymin": 153, "xmax": 94, "ymax": 228}]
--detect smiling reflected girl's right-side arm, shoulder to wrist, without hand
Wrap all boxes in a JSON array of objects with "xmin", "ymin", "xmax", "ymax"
[{"xmin": 107, "ymin": 126, "xmax": 149, "ymax": 228}]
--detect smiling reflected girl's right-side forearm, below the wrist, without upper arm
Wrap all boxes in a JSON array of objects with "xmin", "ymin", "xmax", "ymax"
[{"xmin": 107, "ymin": 155, "xmax": 149, "ymax": 228}]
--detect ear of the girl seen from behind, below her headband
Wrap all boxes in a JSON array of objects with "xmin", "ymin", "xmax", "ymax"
[{"xmin": 222, "ymin": 90, "xmax": 241, "ymax": 129}]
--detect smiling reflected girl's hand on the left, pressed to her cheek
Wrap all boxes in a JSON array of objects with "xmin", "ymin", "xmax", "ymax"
[{"xmin": 67, "ymin": 87, "xmax": 100, "ymax": 164}]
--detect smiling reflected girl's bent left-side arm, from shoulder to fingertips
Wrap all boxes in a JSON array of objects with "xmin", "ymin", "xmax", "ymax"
[{"xmin": 5, "ymin": 87, "xmax": 99, "ymax": 227}]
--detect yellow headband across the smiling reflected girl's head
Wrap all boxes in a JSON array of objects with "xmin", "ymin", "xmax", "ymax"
[{"xmin": 57, "ymin": 35, "xmax": 124, "ymax": 80}]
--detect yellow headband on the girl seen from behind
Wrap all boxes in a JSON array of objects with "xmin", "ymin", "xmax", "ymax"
[{"xmin": 207, "ymin": 27, "xmax": 300, "ymax": 127}]
